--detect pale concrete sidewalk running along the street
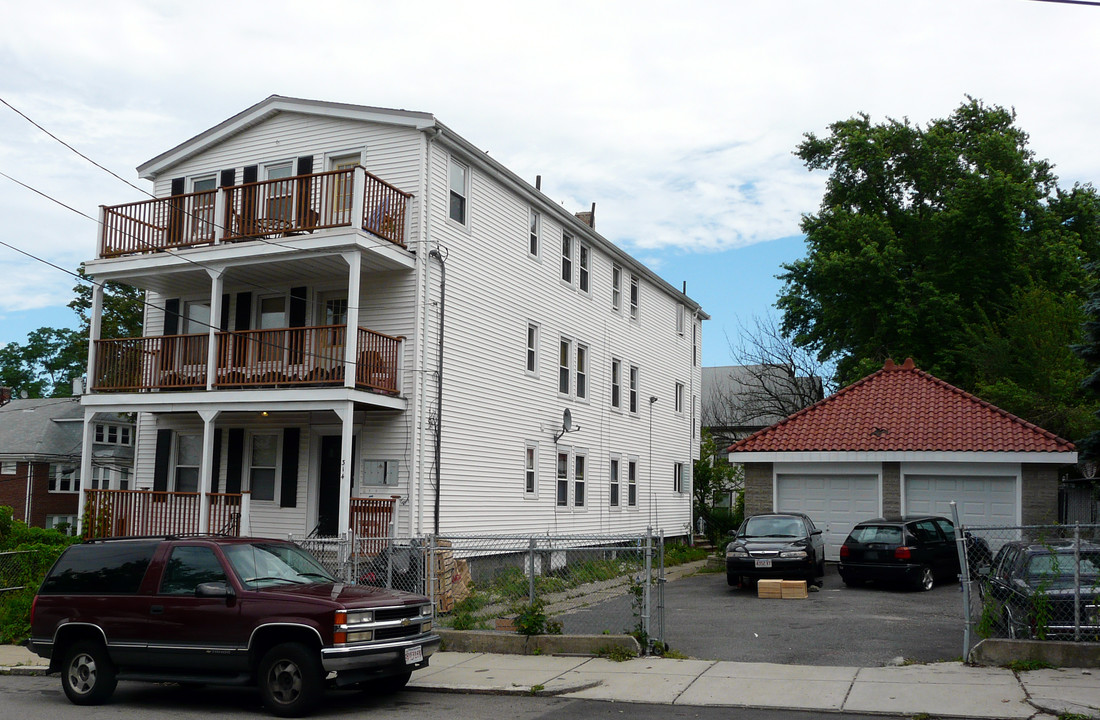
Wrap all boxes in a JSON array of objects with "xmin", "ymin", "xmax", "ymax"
[{"xmin": 0, "ymin": 645, "xmax": 1100, "ymax": 720}]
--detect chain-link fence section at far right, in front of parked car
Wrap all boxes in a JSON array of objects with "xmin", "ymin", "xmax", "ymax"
[{"xmin": 960, "ymin": 524, "xmax": 1100, "ymax": 652}]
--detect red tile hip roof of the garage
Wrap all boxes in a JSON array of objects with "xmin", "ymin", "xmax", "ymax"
[{"xmin": 729, "ymin": 358, "xmax": 1075, "ymax": 453}]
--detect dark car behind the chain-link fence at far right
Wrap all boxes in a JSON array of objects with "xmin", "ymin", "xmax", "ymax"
[{"xmin": 979, "ymin": 540, "xmax": 1100, "ymax": 641}]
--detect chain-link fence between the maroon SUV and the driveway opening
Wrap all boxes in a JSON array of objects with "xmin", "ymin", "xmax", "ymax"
[{"xmin": 294, "ymin": 534, "xmax": 664, "ymax": 649}]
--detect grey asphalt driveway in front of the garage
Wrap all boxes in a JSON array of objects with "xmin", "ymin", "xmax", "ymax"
[{"xmin": 561, "ymin": 565, "xmax": 963, "ymax": 667}]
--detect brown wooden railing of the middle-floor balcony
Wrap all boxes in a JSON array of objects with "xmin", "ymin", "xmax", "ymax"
[{"xmin": 91, "ymin": 325, "xmax": 404, "ymax": 395}]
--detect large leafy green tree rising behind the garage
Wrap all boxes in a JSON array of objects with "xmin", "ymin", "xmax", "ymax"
[{"xmin": 777, "ymin": 98, "xmax": 1100, "ymax": 436}]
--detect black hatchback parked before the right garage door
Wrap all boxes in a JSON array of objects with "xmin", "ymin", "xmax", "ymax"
[{"xmin": 837, "ymin": 516, "xmax": 968, "ymax": 590}]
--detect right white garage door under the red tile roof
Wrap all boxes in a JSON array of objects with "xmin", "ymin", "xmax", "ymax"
[{"xmin": 905, "ymin": 475, "xmax": 1016, "ymax": 527}]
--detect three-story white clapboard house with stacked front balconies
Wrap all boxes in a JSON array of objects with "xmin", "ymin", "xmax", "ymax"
[{"xmin": 83, "ymin": 96, "xmax": 707, "ymax": 536}]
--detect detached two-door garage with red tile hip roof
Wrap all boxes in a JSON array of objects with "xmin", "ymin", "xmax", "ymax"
[{"xmin": 729, "ymin": 359, "xmax": 1077, "ymax": 560}]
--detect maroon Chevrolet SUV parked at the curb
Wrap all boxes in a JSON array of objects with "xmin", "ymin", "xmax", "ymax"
[{"xmin": 28, "ymin": 535, "xmax": 439, "ymax": 717}]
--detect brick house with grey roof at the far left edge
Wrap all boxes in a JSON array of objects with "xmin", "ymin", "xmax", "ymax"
[{"xmin": 0, "ymin": 398, "xmax": 134, "ymax": 529}]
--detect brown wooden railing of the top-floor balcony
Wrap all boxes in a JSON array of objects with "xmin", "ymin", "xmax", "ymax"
[{"xmin": 99, "ymin": 167, "xmax": 413, "ymax": 258}]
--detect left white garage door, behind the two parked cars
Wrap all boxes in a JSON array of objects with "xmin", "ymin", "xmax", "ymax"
[{"xmin": 776, "ymin": 474, "xmax": 879, "ymax": 560}]
